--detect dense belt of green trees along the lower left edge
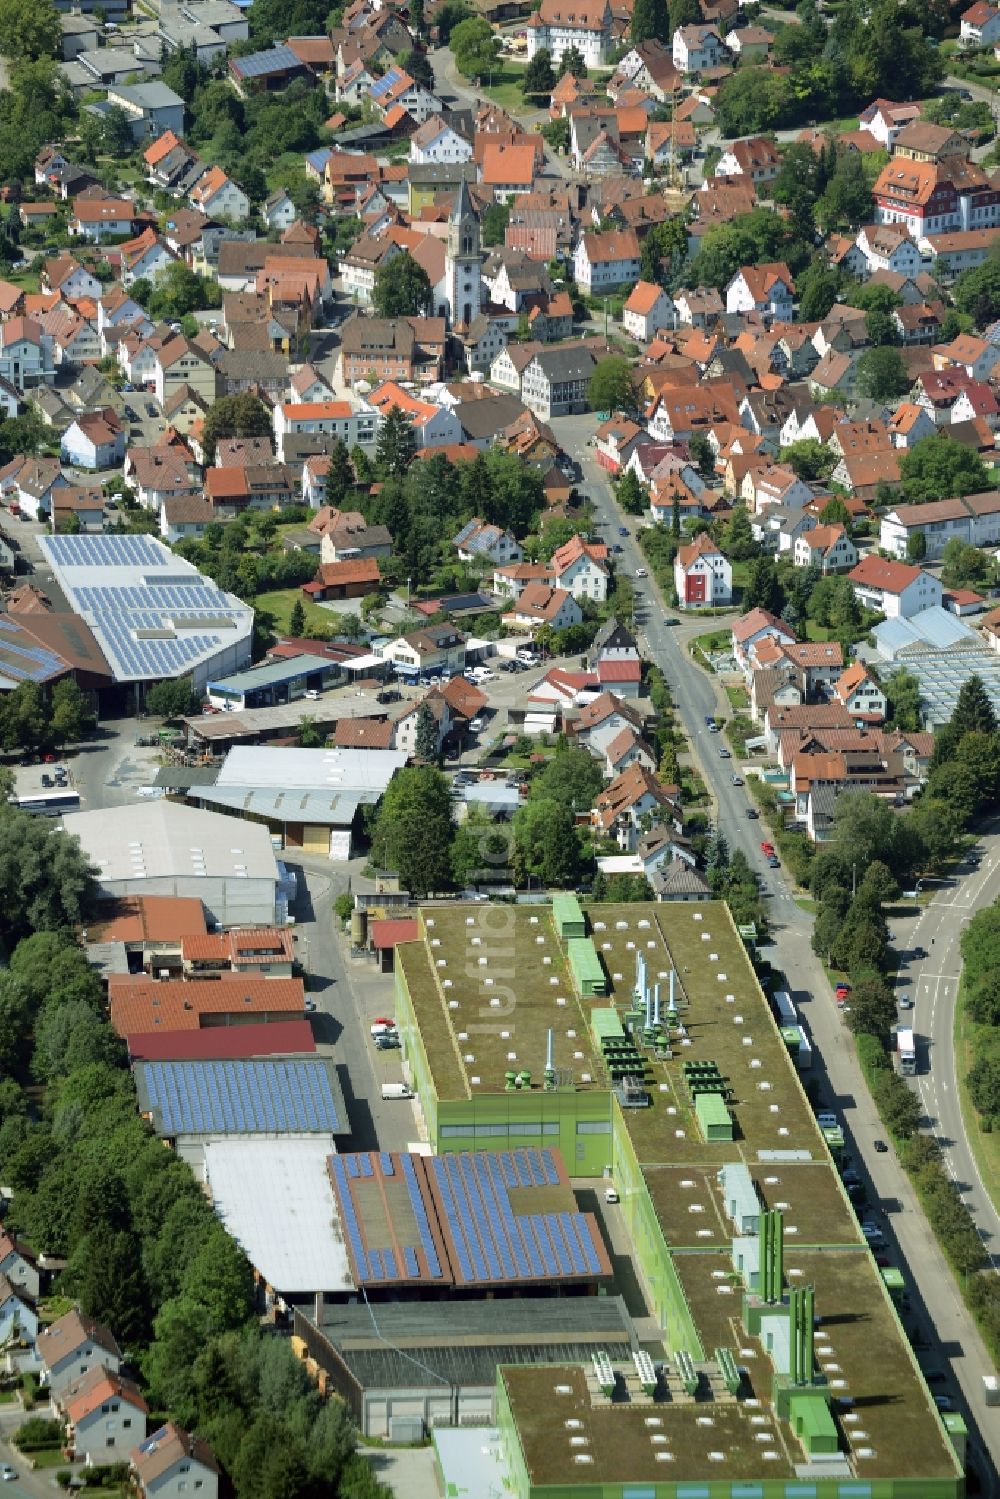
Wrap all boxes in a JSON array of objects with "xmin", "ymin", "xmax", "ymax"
[{"xmin": 0, "ymin": 809, "xmax": 387, "ymax": 1499}]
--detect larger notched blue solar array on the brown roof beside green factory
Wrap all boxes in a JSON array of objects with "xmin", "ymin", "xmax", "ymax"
[{"xmin": 430, "ymin": 1150, "xmax": 601, "ymax": 1283}]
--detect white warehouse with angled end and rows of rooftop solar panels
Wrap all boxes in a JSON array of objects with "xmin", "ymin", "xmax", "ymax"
[{"xmin": 39, "ymin": 535, "xmax": 253, "ymax": 697}]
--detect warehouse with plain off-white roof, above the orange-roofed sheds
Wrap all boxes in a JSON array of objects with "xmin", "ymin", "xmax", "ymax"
[{"xmin": 63, "ymin": 809, "xmax": 286, "ymax": 926}]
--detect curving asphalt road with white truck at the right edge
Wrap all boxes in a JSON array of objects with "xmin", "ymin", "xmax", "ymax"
[{"xmin": 892, "ymin": 830, "xmax": 1000, "ymax": 1265}]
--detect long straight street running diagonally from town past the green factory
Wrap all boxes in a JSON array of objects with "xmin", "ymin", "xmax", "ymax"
[{"xmin": 552, "ymin": 415, "xmax": 1000, "ymax": 1493}]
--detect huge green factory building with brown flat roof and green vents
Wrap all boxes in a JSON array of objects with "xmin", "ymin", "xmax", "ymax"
[{"xmin": 396, "ymin": 901, "xmax": 966, "ymax": 1499}]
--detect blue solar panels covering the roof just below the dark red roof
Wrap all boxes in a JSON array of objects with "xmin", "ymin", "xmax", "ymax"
[{"xmin": 136, "ymin": 1057, "xmax": 345, "ymax": 1135}]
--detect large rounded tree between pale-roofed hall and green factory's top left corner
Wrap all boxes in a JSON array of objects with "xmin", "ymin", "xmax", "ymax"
[{"xmin": 372, "ymin": 766, "xmax": 451, "ymax": 895}]
